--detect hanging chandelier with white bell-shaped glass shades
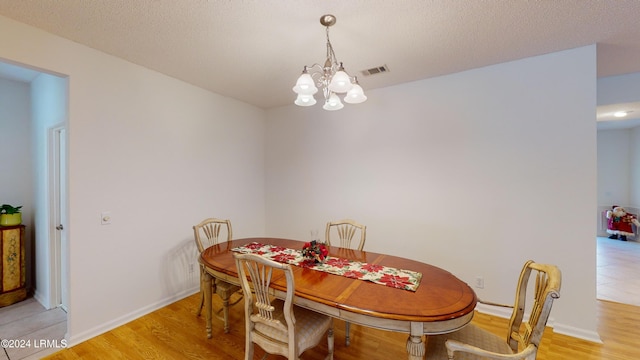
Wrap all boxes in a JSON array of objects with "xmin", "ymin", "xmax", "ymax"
[{"xmin": 293, "ymin": 15, "xmax": 367, "ymax": 110}]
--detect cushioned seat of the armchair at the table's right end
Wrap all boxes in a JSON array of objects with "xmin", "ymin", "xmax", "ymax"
[{"xmin": 427, "ymin": 324, "xmax": 513, "ymax": 360}]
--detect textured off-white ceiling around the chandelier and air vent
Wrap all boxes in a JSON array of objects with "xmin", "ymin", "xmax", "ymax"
[{"xmin": 0, "ymin": 0, "xmax": 640, "ymax": 115}]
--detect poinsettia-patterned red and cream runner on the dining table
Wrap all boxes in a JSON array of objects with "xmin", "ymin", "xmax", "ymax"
[{"xmin": 231, "ymin": 242, "xmax": 422, "ymax": 291}]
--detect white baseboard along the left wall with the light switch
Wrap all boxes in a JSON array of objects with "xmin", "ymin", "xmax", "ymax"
[{"xmin": 67, "ymin": 285, "xmax": 200, "ymax": 347}]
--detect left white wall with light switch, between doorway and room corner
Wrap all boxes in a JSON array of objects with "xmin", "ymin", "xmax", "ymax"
[{"xmin": 0, "ymin": 17, "xmax": 265, "ymax": 344}]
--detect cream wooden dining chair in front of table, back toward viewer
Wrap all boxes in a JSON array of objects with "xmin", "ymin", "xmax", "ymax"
[{"xmin": 233, "ymin": 253, "xmax": 333, "ymax": 360}]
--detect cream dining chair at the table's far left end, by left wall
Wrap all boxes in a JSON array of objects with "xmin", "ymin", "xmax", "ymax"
[{"xmin": 193, "ymin": 218, "xmax": 242, "ymax": 333}]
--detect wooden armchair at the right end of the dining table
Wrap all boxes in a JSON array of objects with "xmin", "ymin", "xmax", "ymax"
[{"xmin": 426, "ymin": 260, "xmax": 562, "ymax": 360}]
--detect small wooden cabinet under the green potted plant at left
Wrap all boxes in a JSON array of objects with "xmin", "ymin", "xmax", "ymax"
[{"xmin": 0, "ymin": 225, "xmax": 27, "ymax": 307}]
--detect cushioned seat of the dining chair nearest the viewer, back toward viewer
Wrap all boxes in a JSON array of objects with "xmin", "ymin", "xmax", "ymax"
[{"xmin": 253, "ymin": 300, "xmax": 331, "ymax": 353}]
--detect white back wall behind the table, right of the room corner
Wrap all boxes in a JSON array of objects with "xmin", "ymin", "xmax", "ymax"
[{"xmin": 266, "ymin": 46, "xmax": 598, "ymax": 339}]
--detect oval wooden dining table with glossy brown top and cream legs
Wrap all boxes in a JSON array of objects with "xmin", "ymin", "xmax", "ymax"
[{"xmin": 199, "ymin": 237, "xmax": 477, "ymax": 360}]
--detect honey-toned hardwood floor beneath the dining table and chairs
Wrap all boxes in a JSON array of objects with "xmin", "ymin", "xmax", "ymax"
[{"xmin": 37, "ymin": 294, "xmax": 640, "ymax": 360}]
